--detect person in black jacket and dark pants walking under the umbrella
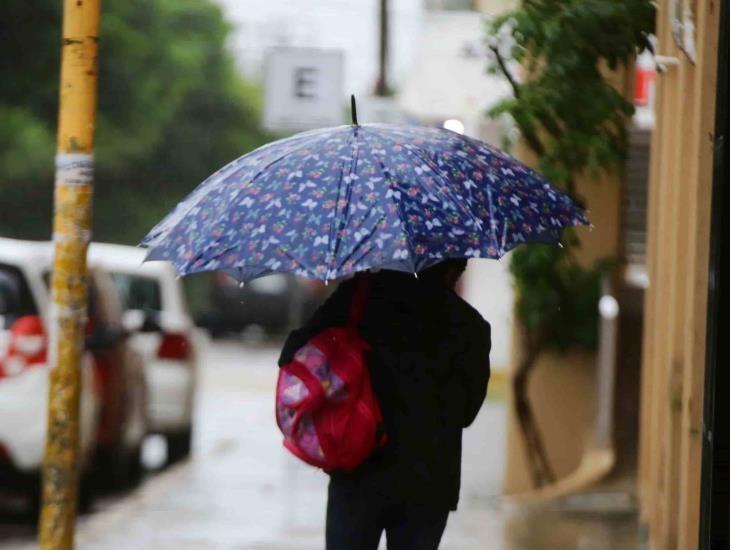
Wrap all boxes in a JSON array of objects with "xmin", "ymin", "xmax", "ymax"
[{"xmin": 279, "ymin": 259, "xmax": 491, "ymax": 550}]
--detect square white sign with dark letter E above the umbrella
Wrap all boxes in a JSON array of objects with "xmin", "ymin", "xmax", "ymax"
[{"xmin": 263, "ymin": 48, "xmax": 344, "ymax": 132}]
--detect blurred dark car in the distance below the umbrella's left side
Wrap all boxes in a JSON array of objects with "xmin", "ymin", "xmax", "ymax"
[{"xmin": 206, "ymin": 272, "xmax": 327, "ymax": 336}]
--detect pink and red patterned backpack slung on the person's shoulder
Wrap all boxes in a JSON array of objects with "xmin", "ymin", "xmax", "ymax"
[{"xmin": 276, "ymin": 276, "xmax": 386, "ymax": 471}]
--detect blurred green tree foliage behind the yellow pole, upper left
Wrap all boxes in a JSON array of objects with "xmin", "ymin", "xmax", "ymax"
[{"xmin": 0, "ymin": 0, "xmax": 267, "ymax": 243}]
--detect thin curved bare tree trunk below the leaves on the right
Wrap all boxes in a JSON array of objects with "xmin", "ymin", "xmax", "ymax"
[{"xmin": 512, "ymin": 333, "xmax": 555, "ymax": 487}]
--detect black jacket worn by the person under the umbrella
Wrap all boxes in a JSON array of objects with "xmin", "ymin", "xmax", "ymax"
[{"xmin": 279, "ymin": 271, "xmax": 491, "ymax": 510}]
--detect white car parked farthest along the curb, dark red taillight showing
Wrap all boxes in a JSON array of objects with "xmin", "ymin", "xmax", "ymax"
[{"xmin": 89, "ymin": 243, "xmax": 202, "ymax": 462}]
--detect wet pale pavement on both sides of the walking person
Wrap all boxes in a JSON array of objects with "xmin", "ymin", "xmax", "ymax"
[{"xmin": 0, "ymin": 342, "xmax": 636, "ymax": 550}]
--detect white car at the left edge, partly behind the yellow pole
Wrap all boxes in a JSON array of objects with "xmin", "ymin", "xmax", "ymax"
[{"xmin": 0, "ymin": 238, "xmax": 101, "ymax": 501}]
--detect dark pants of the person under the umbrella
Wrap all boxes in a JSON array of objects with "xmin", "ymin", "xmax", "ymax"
[{"xmin": 327, "ymin": 479, "xmax": 449, "ymax": 550}]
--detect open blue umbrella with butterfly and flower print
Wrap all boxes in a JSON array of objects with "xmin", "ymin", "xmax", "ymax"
[{"xmin": 142, "ymin": 98, "xmax": 588, "ymax": 282}]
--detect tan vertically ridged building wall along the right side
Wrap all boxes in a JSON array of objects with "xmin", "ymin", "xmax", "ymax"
[{"xmin": 639, "ymin": 0, "xmax": 720, "ymax": 550}]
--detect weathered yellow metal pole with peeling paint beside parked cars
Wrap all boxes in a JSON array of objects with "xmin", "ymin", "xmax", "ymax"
[{"xmin": 39, "ymin": 0, "xmax": 99, "ymax": 550}]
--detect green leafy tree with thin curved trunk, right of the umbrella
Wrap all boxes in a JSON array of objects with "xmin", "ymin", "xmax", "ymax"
[{"xmin": 487, "ymin": 0, "xmax": 655, "ymax": 486}]
